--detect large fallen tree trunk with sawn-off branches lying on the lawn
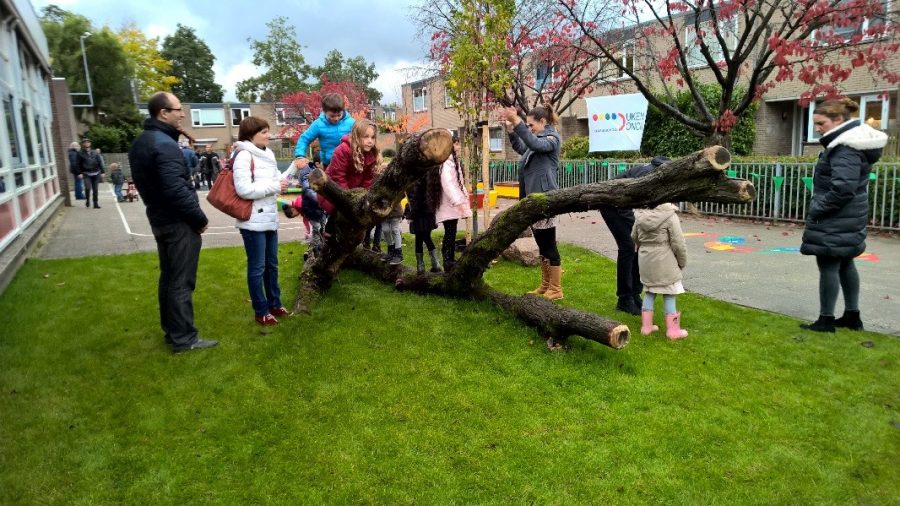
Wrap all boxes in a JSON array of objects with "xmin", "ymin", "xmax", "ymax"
[{"xmin": 294, "ymin": 129, "xmax": 755, "ymax": 349}]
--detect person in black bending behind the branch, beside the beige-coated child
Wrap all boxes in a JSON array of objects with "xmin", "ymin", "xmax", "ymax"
[{"xmin": 600, "ymin": 156, "xmax": 669, "ymax": 315}]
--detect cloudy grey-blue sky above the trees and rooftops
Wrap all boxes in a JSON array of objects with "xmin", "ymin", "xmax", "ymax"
[{"xmin": 32, "ymin": 0, "xmax": 426, "ymax": 103}]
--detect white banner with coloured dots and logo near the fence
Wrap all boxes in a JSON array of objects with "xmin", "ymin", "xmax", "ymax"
[{"xmin": 584, "ymin": 93, "xmax": 647, "ymax": 151}]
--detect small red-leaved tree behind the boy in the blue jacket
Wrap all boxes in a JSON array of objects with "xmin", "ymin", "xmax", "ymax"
[{"xmin": 280, "ymin": 74, "xmax": 369, "ymax": 142}]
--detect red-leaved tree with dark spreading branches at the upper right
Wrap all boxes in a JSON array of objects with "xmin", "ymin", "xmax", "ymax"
[{"xmin": 556, "ymin": 0, "xmax": 900, "ymax": 146}]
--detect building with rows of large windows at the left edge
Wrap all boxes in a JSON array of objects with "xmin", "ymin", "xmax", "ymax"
[{"xmin": 0, "ymin": 0, "xmax": 65, "ymax": 291}]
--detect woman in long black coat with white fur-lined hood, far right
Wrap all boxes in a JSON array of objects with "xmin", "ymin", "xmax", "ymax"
[{"xmin": 800, "ymin": 98, "xmax": 887, "ymax": 332}]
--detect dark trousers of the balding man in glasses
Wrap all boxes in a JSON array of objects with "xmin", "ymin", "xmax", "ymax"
[{"xmin": 151, "ymin": 222, "xmax": 203, "ymax": 351}]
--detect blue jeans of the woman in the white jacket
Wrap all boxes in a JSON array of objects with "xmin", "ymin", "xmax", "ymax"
[{"xmin": 240, "ymin": 229, "xmax": 281, "ymax": 316}]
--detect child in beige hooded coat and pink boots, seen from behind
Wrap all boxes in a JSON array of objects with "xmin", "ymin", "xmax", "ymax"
[{"xmin": 631, "ymin": 203, "xmax": 688, "ymax": 339}]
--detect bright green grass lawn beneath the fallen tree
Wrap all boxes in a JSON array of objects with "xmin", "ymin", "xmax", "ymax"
[{"xmin": 0, "ymin": 243, "xmax": 900, "ymax": 504}]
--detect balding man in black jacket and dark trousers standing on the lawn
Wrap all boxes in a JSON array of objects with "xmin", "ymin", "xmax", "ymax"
[{"xmin": 128, "ymin": 92, "xmax": 218, "ymax": 353}]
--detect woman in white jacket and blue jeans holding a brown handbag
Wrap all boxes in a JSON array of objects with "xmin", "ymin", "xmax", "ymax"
[{"xmin": 234, "ymin": 116, "xmax": 288, "ymax": 325}]
